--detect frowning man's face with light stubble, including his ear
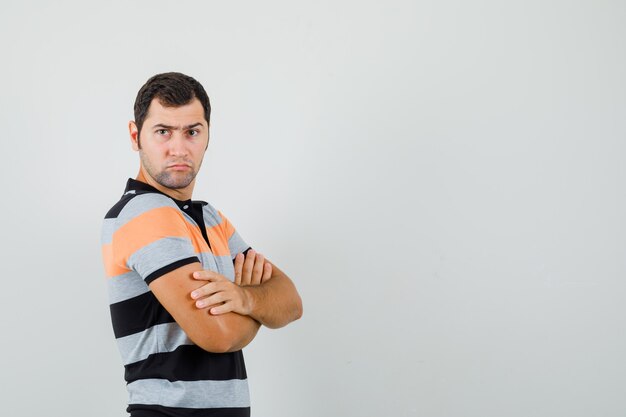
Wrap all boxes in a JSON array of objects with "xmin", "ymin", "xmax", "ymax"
[{"xmin": 131, "ymin": 99, "xmax": 209, "ymax": 190}]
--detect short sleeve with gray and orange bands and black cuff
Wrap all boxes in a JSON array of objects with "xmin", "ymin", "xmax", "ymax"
[{"xmin": 111, "ymin": 194, "xmax": 199, "ymax": 284}]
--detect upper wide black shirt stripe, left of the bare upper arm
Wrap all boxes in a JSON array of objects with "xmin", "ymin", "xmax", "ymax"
[{"xmin": 110, "ymin": 291, "xmax": 174, "ymax": 338}]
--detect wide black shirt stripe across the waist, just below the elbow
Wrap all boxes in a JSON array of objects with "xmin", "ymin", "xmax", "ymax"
[{"xmin": 124, "ymin": 345, "xmax": 248, "ymax": 383}]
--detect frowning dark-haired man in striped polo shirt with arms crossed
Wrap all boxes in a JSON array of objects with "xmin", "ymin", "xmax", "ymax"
[{"xmin": 102, "ymin": 73, "xmax": 302, "ymax": 417}]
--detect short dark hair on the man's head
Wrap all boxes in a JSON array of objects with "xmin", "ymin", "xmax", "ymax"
[{"xmin": 135, "ymin": 72, "xmax": 211, "ymax": 138}]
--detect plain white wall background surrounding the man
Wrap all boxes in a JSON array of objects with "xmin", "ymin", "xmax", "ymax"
[{"xmin": 0, "ymin": 0, "xmax": 626, "ymax": 417}]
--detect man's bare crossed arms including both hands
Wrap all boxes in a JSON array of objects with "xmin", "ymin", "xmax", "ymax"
[{"xmin": 150, "ymin": 250, "xmax": 302, "ymax": 353}]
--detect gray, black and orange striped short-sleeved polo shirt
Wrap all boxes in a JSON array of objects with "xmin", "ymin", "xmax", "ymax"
[{"xmin": 102, "ymin": 179, "xmax": 250, "ymax": 417}]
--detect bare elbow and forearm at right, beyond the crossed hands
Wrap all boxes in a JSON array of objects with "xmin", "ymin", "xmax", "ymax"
[{"xmin": 244, "ymin": 265, "xmax": 302, "ymax": 329}]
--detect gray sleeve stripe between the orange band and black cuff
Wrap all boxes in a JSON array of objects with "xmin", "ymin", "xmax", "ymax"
[{"xmin": 128, "ymin": 237, "xmax": 197, "ymax": 279}]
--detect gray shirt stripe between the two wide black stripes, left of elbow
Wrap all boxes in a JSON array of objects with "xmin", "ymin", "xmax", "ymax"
[{"xmin": 117, "ymin": 323, "xmax": 194, "ymax": 365}]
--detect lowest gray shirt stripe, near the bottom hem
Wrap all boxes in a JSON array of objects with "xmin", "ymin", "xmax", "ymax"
[{"xmin": 127, "ymin": 379, "xmax": 250, "ymax": 408}]
